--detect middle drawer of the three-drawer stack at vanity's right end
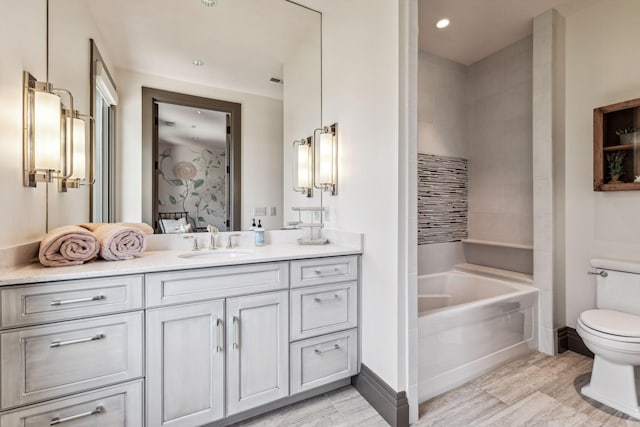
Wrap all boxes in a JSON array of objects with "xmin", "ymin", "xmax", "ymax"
[{"xmin": 290, "ymin": 282, "xmax": 358, "ymax": 341}]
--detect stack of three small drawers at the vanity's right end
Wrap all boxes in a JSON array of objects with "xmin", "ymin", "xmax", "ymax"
[{"xmin": 290, "ymin": 256, "xmax": 359, "ymax": 402}]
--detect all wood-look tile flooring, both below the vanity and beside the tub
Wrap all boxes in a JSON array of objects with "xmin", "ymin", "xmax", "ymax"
[{"xmin": 231, "ymin": 351, "xmax": 640, "ymax": 427}]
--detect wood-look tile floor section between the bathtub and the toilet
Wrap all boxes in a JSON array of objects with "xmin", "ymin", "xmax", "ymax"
[{"xmin": 414, "ymin": 351, "xmax": 640, "ymax": 427}]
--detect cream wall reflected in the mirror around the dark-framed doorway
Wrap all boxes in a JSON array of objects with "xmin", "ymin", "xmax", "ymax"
[{"xmin": 116, "ymin": 70, "xmax": 283, "ymax": 229}]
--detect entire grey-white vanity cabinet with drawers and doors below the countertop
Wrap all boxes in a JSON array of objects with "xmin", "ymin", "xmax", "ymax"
[{"xmin": 0, "ymin": 255, "xmax": 360, "ymax": 427}]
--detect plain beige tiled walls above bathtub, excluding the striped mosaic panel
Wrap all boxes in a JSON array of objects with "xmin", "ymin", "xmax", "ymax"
[{"xmin": 418, "ymin": 37, "xmax": 533, "ymax": 251}]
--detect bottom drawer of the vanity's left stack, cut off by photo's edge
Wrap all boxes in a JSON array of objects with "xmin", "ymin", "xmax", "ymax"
[{"xmin": 0, "ymin": 380, "xmax": 143, "ymax": 427}]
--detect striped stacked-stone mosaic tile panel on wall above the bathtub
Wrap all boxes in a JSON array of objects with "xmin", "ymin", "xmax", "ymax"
[{"xmin": 418, "ymin": 153, "xmax": 469, "ymax": 245}]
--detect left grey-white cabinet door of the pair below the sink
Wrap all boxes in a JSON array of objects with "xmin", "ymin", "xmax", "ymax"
[{"xmin": 146, "ymin": 300, "xmax": 224, "ymax": 427}]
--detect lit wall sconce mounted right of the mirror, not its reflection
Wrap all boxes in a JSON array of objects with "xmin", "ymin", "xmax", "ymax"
[{"xmin": 313, "ymin": 123, "xmax": 338, "ymax": 196}]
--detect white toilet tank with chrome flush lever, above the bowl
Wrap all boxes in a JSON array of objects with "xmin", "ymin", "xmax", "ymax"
[{"xmin": 591, "ymin": 260, "xmax": 640, "ymax": 315}]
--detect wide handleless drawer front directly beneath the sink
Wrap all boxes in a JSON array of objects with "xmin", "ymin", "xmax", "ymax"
[{"xmin": 145, "ymin": 262, "xmax": 289, "ymax": 307}]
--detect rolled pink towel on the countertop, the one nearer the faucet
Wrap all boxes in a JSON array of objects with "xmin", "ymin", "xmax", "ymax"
[{"xmin": 80, "ymin": 223, "xmax": 148, "ymax": 261}]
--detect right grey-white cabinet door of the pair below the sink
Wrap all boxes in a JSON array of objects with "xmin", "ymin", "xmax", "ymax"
[{"xmin": 227, "ymin": 292, "xmax": 289, "ymax": 415}]
